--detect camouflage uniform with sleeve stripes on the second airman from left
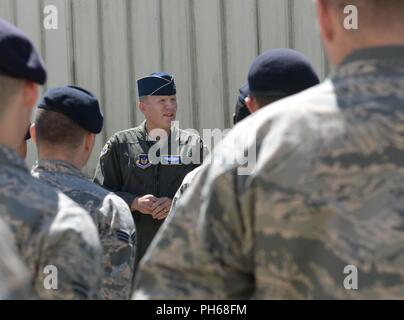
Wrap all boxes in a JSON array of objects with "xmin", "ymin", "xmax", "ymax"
[{"xmin": 31, "ymin": 160, "xmax": 136, "ymax": 299}]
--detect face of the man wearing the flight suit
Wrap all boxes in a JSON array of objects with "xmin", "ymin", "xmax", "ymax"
[{"xmin": 139, "ymin": 96, "xmax": 177, "ymax": 130}]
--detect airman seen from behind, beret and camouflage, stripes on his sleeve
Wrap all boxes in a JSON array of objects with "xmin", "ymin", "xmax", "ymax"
[{"xmin": 31, "ymin": 86, "xmax": 136, "ymax": 299}]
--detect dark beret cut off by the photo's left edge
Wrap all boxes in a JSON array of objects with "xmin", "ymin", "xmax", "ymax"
[{"xmin": 0, "ymin": 19, "xmax": 46, "ymax": 84}]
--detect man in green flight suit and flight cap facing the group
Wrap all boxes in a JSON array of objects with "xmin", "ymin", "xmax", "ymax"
[{"xmin": 95, "ymin": 72, "xmax": 203, "ymax": 268}]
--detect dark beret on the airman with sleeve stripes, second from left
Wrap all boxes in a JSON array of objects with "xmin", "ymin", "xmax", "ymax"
[{"xmin": 38, "ymin": 86, "xmax": 104, "ymax": 133}]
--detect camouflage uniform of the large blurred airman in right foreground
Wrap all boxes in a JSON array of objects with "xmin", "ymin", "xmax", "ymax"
[{"xmin": 135, "ymin": 47, "xmax": 404, "ymax": 299}]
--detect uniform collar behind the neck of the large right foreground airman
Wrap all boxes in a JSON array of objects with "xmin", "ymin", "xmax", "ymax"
[{"xmin": 339, "ymin": 45, "xmax": 404, "ymax": 67}]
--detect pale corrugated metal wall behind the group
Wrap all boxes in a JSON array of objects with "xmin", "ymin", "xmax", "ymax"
[{"xmin": 0, "ymin": 0, "xmax": 328, "ymax": 175}]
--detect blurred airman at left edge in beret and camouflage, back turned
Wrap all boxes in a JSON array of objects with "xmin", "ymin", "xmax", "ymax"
[{"xmin": 0, "ymin": 19, "xmax": 102, "ymax": 299}]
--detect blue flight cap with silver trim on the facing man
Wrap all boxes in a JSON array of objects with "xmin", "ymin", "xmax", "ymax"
[{"xmin": 137, "ymin": 72, "xmax": 177, "ymax": 97}]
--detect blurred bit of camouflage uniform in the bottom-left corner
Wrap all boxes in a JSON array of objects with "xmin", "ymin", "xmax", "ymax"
[{"xmin": 0, "ymin": 219, "xmax": 29, "ymax": 300}]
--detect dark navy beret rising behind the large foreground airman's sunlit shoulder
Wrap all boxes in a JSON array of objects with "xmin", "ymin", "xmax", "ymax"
[{"xmin": 248, "ymin": 49, "xmax": 320, "ymax": 97}]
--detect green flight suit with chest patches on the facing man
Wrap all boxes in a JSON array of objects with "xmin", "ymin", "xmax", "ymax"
[{"xmin": 94, "ymin": 121, "xmax": 204, "ymax": 265}]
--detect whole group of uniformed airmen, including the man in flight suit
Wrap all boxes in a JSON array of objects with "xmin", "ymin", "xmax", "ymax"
[{"xmin": 0, "ymin": 0, "xmax": 404, "ymax": 300}]
